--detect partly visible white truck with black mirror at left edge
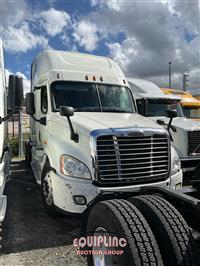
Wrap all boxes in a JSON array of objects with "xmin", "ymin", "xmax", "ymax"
[{"xmin": 0, "ymin": 39, "xmax": 23, "ymax": 239}]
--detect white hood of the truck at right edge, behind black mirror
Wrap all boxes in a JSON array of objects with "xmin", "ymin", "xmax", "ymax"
[{"xmin": 151, "ymin": 116, "xmax": 200, "ymax": 131}]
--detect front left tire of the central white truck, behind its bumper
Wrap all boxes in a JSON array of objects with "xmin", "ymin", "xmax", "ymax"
[{"xmin": 41, "ymin": 164, "xmax": 60, "ymax": 218}]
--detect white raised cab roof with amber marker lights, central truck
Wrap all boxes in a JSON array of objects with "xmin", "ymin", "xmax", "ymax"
[{"xmin": 32, "ymin": 50, "xmax": 128, "ymax": 86}]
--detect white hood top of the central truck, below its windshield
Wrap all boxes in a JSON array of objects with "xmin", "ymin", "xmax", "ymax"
[{"xmin": 69, "ymin": 112, "xmax": 163, "ymax": 135}]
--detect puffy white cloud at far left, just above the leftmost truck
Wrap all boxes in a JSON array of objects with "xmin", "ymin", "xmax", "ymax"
[{"xmin": 3, "ymin": 22, "xmax": 48, "ymax": 53}]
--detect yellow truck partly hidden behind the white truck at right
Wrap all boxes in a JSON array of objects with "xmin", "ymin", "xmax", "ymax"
[{"xmin": 162, "ymin": 88, "xmax": 200, "ymax": 120}]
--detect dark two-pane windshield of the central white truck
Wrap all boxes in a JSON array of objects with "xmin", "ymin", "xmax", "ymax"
[{"xmin": 51, "ymin": 82, "xmax": 135, "ymax": 113}]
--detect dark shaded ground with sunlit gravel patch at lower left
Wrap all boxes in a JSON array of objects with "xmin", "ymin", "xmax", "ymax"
[{"xmin": 0, "ymin": 161, "xmax": 87, "ymax": 266}]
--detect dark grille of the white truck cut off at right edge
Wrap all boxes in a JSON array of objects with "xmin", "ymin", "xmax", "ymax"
[{"xmin": 188, "ymin": 131, "xmax": 200, "ymax": 155}]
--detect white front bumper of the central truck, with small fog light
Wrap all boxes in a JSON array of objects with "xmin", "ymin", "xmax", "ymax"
[{"xmin": 51, "ymin": 171, "xmax": 182, "ymax": 214}]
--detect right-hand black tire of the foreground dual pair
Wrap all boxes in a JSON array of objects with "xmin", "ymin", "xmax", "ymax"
[{"xmin": 130, "ymin": 195, "xmax": 200, "ymax": 266}]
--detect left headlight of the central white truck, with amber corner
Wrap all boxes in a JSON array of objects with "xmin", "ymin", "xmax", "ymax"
[{"xmin": 60, "ymin": 154, "xmax": 91, "ymax": 179}]
